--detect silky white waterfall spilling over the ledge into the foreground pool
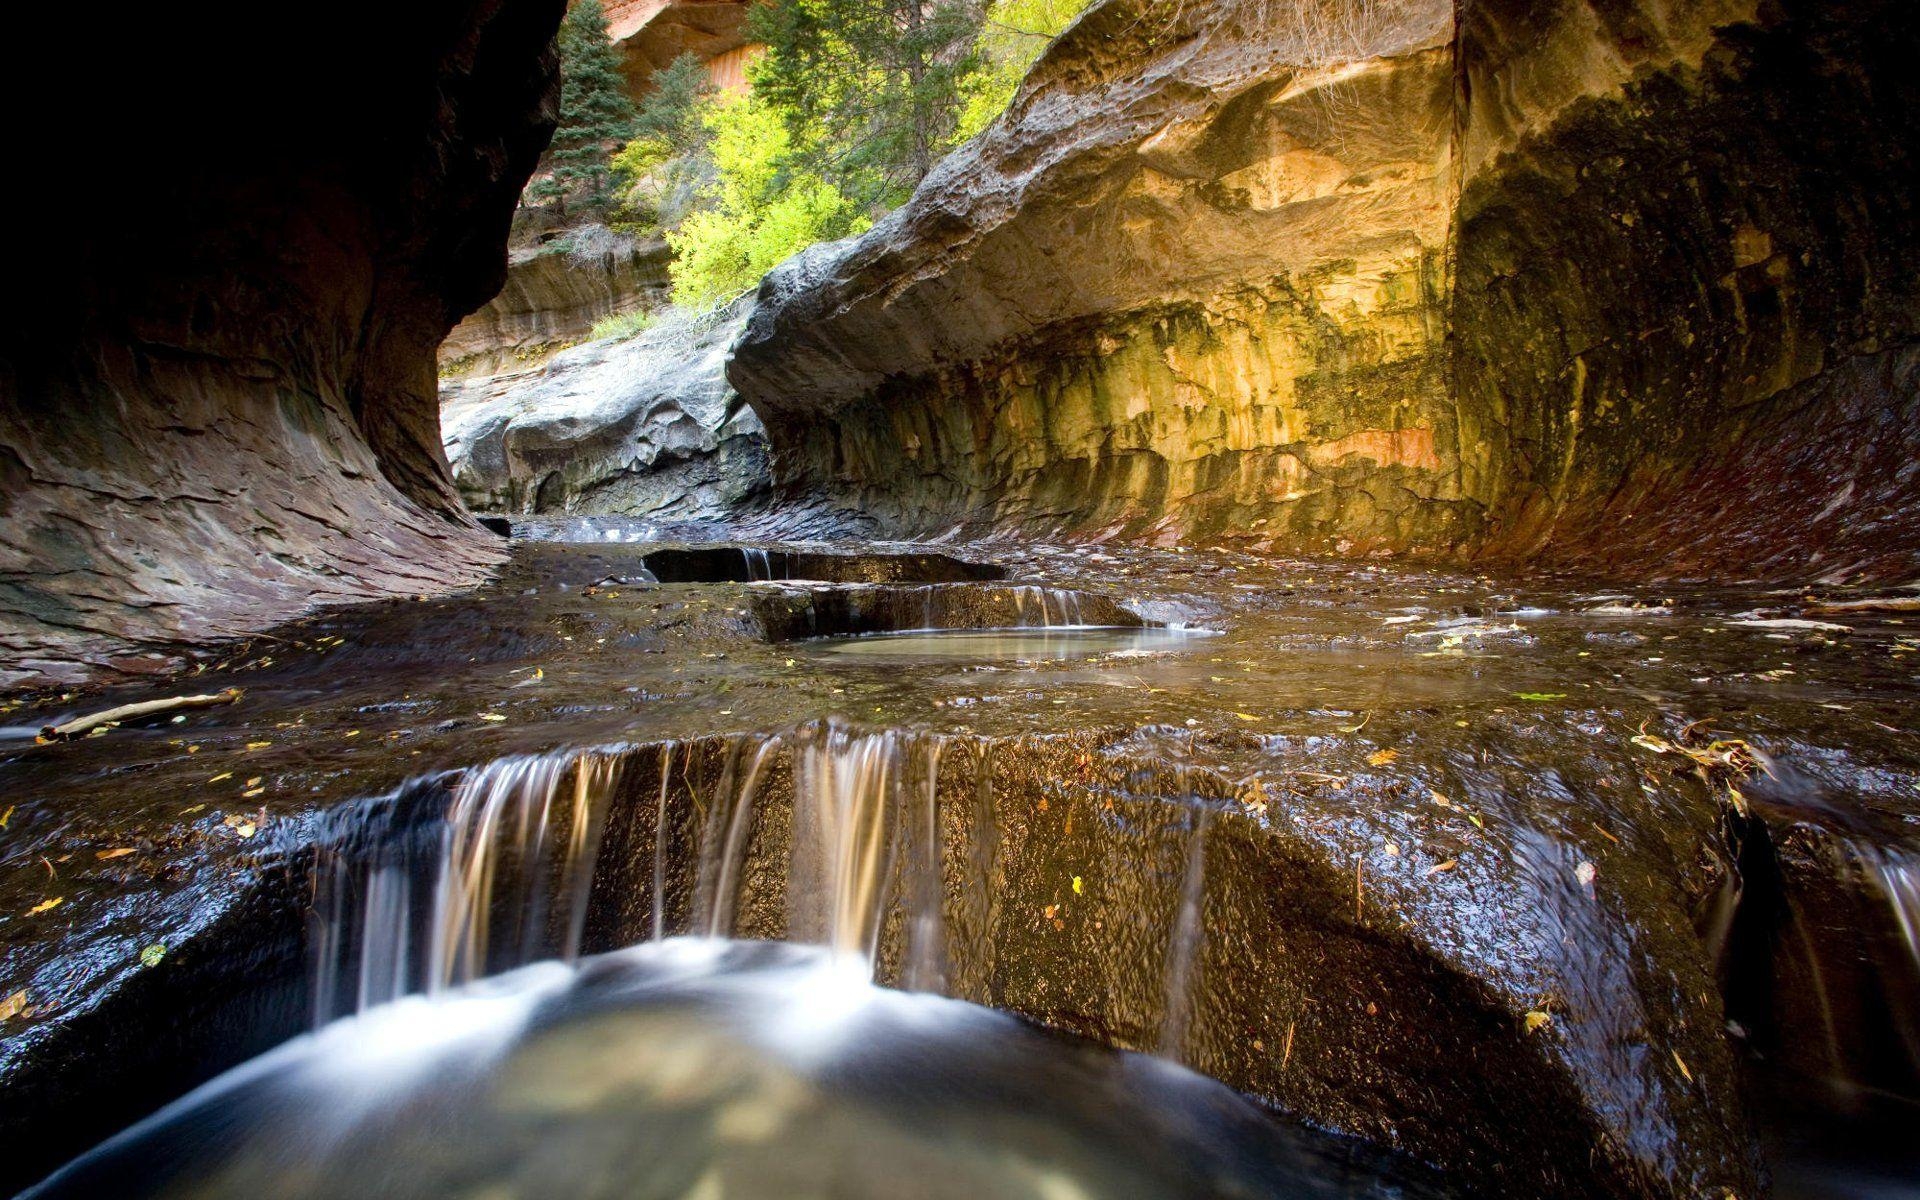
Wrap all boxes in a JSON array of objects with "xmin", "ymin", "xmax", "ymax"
[{"xmin": 311, "ymin": 724, "xmax": 960, "ymax": 1023}]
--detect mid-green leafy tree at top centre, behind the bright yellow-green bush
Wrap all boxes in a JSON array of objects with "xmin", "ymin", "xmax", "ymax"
[{"xmin": 747, "ymin": 0, "xmax": 985, "ymax": 211}]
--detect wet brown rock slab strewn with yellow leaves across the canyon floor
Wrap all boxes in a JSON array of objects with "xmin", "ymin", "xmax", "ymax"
[{"xmin": 0, "ymin": 530, "xmax": 1920, "ymax": 1196}]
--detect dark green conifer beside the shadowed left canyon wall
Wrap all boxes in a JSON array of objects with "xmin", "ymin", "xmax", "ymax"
[{"xmin": 528, "ymin": 0, "xmax": 636, "ymax": 215}]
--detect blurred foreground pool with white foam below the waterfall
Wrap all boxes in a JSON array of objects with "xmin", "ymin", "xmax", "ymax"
[{"xmin": 29, "ymin": 939, "xmax": 1440, "ymax": 1200}]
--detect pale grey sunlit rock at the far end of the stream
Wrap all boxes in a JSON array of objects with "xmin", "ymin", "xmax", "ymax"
[{"xmin": 442, "ymin": 300, "xmax": 768, "ymax": 518}]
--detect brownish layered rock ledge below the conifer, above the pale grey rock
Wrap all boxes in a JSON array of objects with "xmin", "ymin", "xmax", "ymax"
[{"xmin": 440, "ymin": 236, "xmax": 672, "ymax": 376}]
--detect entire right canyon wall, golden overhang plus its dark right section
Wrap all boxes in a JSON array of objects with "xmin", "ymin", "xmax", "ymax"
[{"xmin": 733, "ymin": 0, "xmax": 1920, "ymax": 576}]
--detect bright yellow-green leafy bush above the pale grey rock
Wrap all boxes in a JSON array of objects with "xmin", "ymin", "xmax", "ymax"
[{"xmin": 666, "ymin": 94, "xmax": 872, "ymax": 307}]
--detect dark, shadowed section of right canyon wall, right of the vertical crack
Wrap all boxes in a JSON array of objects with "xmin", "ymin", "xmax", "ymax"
[{"xmin": 1452, "ymin": 0, "xmax": 1920, "ymax": 582}]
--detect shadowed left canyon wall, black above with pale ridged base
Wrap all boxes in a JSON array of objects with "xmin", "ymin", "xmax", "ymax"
[{"xmin": 0, "ymin": 0, "xmax": 564, "ymax": 685}]
